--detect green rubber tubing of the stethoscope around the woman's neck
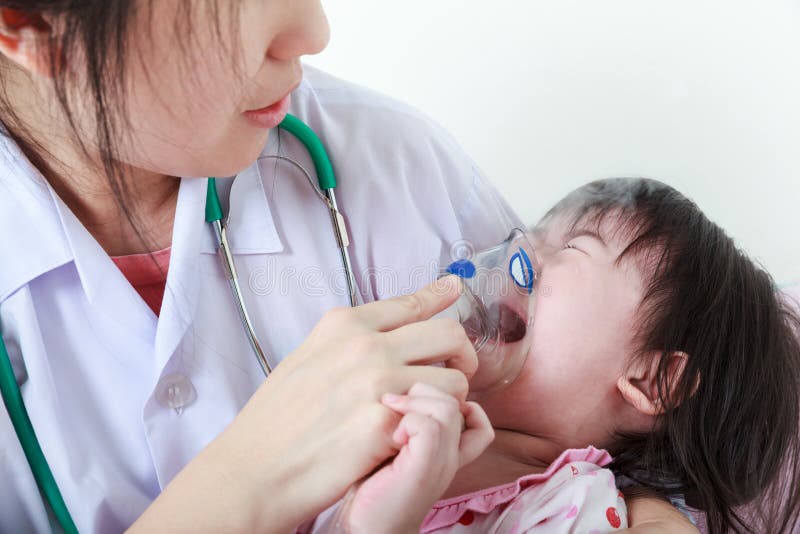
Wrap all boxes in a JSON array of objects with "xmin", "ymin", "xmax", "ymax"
[{"xmin": 0, "ymin": 111, "xmax": 336, "ymax": 534}]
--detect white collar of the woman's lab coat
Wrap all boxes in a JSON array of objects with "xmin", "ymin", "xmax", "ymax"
[{"xmin": 0, "ymin": 128, "xmax": 283, "ymax": 308}]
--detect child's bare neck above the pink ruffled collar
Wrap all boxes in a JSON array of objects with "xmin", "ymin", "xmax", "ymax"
[{"xmin": 442, "ymin": 429, "xmax": 564, "ymax": 499}]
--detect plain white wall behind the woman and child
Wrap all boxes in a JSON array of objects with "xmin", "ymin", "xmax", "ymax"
[{"xmin": 308, "ymin": 0, "xmax": 800, "ymax": 283}]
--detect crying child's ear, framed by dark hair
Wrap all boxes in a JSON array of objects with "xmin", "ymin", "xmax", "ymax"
[{"xmin": 617, "ymin": 351, "xmax": 689, "ymax": 416}]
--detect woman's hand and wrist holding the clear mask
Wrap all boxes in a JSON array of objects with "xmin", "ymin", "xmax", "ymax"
[{"xmin": 130, "ymin": 277, "xmax": 477, "ymax": 532}]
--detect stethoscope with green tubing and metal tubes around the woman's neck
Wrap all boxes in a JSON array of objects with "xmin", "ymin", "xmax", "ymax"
[{"xmin": 0, "ymin": 115, "xmax": 358, "ymax": 533}]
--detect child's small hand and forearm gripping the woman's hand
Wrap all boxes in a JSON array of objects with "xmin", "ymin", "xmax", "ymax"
[{"xmin": 348, "ymin": 384, "xmax": 494, "ymax": 533}]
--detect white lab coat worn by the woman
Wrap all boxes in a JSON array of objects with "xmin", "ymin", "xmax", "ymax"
[{"xmin": 0, "ymin": 68, "xmax": 520, "ymax": 532}]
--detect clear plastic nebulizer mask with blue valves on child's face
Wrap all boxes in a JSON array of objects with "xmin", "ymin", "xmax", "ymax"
[{"xmin": 437, "ymin": 228, "xmax": 541, "ymax": 394}]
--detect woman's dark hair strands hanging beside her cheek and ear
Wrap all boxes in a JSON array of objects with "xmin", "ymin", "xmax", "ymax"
[{"xmin": 0, "ymin": 0, "xmax": 240, "ymax": 252}]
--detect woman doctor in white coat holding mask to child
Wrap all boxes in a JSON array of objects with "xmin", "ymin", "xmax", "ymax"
[{"xmin": 0, "ymin": 0, "xmax": 700, "ymax": 532}]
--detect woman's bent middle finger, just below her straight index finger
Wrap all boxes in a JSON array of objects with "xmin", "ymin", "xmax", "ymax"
[{"xmin": 384, "ymin": 319, "xmax": 478, "ymax": 377}]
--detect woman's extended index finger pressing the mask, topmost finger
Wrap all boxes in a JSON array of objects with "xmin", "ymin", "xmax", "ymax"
[{"xmin": 353, "ymin": 276, "xmax": 461, "ymax": 332}]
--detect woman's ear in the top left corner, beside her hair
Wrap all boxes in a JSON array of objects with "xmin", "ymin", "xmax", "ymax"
[{"xmin": 0, "ymin": 7, "xmax": 58, "ymax": 77}]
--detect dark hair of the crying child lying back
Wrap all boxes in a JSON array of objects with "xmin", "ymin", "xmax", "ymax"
[{"xmin": 544, "ymin": 179, "xmax": 800, "ymax": 533}]
